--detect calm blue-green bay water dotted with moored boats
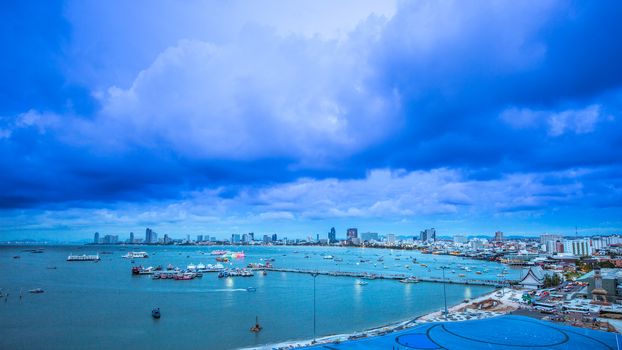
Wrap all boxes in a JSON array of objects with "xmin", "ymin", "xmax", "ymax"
[{"xmin": 0, "ymin": 246, "xmax": 518, "ymax": 349}]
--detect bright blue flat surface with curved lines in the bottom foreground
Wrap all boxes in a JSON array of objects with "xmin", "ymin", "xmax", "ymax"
[{"xmin": 304, "ymin": 315, "xmax": 622, "ymax": 350}]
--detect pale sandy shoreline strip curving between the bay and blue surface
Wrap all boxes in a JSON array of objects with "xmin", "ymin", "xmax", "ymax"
[{"xmin": 239, "ymin": 288, "xmax": 522, "ymax": 350}]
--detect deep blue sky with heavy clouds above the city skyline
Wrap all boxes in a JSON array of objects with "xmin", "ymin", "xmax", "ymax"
[{"xmin": 0, "ymin": 0, "xmax": 622, "ymax": 240}]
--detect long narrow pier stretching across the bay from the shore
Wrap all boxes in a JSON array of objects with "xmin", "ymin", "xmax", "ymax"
[{"xmin": 262, "ymin": 267, "xmax": 513, "ymax": 286}]
